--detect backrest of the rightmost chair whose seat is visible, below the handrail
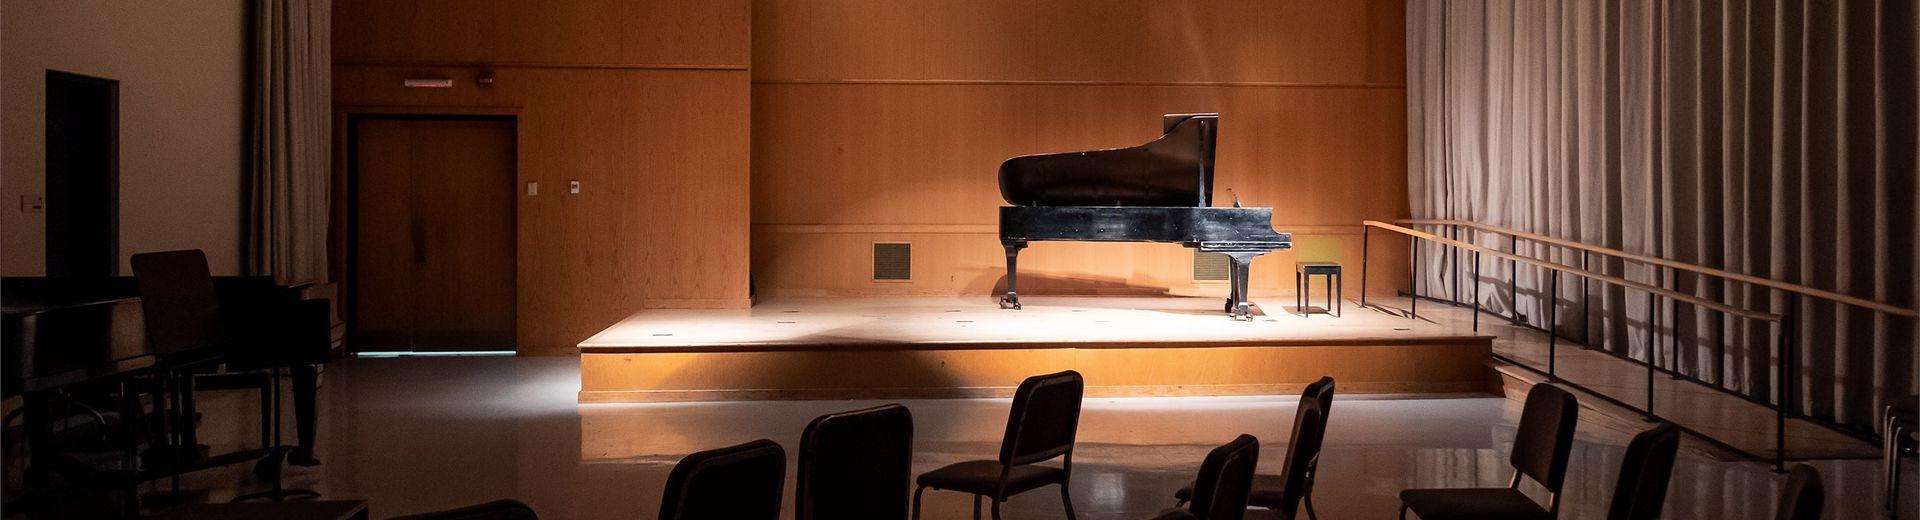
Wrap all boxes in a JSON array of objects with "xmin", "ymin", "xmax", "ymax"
[{"xmin": 1511, "ymin": 384, "xmax": 1580, "ymax": 493}]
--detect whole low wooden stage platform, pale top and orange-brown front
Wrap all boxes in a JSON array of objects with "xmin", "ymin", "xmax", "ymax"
[{"xmin": 580, "ymin": 295, "xmax": 1498, "ymax": 403}]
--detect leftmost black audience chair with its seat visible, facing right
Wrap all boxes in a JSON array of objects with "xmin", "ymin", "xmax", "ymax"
[{"xmin": 914, "ymin": 370, "xmax": 1087, "ymax": 520}]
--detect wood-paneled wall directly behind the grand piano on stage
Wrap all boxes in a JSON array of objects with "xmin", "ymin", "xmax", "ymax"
[{"xmin": 753, "ymin": 0, "xmax": 1407, "ymax": 295}]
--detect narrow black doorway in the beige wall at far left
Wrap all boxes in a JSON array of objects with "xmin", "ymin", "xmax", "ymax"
[{"xmin": 46, "ymin": 71, "xmax": 119, "ymax": 276}]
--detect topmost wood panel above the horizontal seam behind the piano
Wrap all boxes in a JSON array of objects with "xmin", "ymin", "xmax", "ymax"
[{"xmin": 753, "ymin": 0, "xmax": 1405, "ymax": 84}]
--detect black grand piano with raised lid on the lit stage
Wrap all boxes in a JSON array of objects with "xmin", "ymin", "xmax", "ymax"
[{"xmin": 1000, "ymin": 113, "xmax": 1292, "ymax": 320}]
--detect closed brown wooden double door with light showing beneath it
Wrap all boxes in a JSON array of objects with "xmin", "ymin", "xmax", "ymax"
[{"xmin": 348, "ymin": 115, "xmax": 518, "ymax": 351}]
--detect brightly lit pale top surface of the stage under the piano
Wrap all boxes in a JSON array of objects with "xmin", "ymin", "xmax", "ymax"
[{"xmin": 580, "ymin": 295, "xmax": 1492, "ymax": 353}]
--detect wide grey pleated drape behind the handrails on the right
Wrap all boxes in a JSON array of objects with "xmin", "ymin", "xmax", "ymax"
[{"xmin": 1407, "ymin": 0, "xmax": 1920, "ymax": 426}]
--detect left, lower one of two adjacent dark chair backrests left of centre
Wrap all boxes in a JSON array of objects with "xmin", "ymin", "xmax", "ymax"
[{"xmin": 660, "ymin": 439, "xmax": 787, "ymax": 520}]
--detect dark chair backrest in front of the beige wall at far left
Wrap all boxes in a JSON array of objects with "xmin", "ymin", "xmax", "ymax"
[{"xmin": 132, "ymin": 249, "xmax": 221, "ymax": 355}]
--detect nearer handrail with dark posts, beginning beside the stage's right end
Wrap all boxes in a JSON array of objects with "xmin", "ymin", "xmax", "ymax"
[{"xmin": 1359, "ymin": 221, "xmax": 1797, "ymax": 472}]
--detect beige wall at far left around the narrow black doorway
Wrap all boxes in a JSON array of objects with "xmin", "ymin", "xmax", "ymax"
[{"xmin": 0, "ymin": 0, "xmax": 248, "ymax": 276}]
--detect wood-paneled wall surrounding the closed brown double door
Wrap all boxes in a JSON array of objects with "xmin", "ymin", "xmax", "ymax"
[{"xmin": 334, "ymin": 0, "xmax": 751, "ymax": 355}]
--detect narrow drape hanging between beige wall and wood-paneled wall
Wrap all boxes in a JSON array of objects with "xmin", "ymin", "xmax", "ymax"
[{"xmin": 244, "ymin": 0, "xmax": 332, "ymax": 282}]
